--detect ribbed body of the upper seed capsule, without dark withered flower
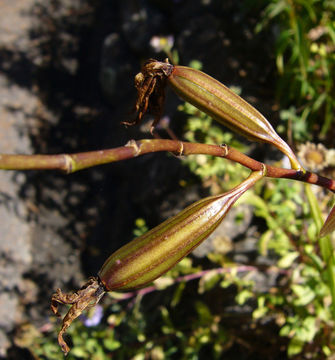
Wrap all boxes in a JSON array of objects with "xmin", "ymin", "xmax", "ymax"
[{"xmin": 168, "ymin": 63, "xmax": 303, "ymax": 170}]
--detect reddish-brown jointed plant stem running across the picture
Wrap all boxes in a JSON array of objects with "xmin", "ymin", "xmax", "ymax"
[{"xmin": 0, "ymin": 139, "xmax": 335, "ymax": 192}]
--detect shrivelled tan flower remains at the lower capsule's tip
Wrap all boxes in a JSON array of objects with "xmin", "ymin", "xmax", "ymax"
[{"xmin": 51, "ymin": 277, "xmax": 105, "ymax": 355}]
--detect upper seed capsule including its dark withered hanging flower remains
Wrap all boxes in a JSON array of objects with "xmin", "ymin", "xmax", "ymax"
[{"xmin": 128, "ymin": 59, "xmax": 305, "ymax": 172}]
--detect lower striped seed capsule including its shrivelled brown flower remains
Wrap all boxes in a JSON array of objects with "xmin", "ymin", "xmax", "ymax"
[{"xmin": 51, "ymin": 167, "xmax": 265, "ymax": 354}]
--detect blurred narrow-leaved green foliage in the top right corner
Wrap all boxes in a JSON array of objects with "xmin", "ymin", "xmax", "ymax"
[{"xmin": 256, "ymin": 0, "xmax": 335, "ymax": 141}]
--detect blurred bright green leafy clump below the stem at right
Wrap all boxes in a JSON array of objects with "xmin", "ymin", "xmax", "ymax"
[{"xmin": 246, "ymin": 180, "xmax": 335, "ymax": 358}]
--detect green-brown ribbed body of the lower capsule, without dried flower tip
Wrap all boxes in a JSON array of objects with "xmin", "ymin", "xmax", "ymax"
[{"xmin": 98, "ymin": 171, "xmax": 263, "ymax": 291}]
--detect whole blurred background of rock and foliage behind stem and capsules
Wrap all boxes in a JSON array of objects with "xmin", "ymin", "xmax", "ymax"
[{"xmin": 0, "ymin": 0, "xmax": 335, "ymax": 360}]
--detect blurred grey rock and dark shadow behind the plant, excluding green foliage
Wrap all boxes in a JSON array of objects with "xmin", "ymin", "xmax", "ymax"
[{"xmin": 0, "ymin": 0, "xmax": 273, "ymax": 359}]
